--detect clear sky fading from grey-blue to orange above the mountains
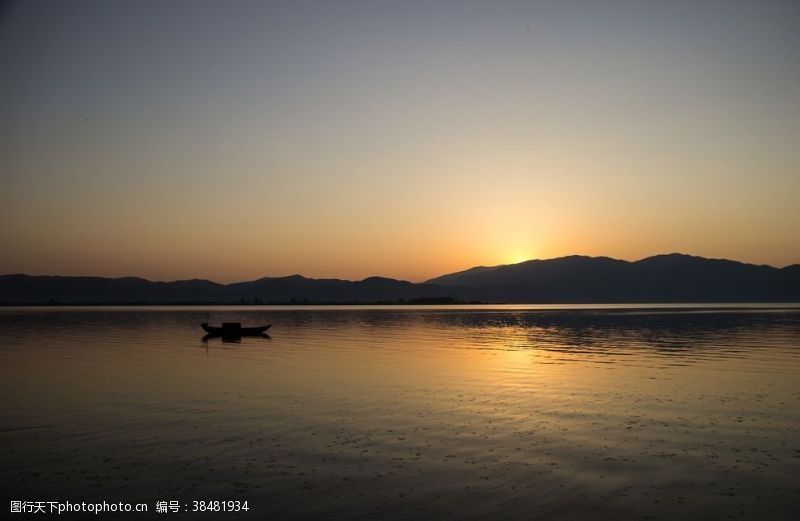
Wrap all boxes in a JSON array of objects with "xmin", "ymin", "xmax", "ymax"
[{"xmin": 0, "ymin": 0, "xmax": 800, "ymax": 282}]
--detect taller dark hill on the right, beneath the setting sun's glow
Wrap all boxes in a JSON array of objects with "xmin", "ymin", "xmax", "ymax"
[{"xmin": 426, "ymin": 253, "xmax": 800, "ymax": 303}]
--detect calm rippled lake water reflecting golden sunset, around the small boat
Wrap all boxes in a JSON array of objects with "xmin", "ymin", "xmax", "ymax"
[{"xmin": 0, "ymin": 307, "xmax": 800, "ymax": 520}]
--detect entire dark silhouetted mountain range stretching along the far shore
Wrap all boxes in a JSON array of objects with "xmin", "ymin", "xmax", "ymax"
[{"xmin": 0, "ymin": 253, "xmax": 800, "ymax": 305}]
